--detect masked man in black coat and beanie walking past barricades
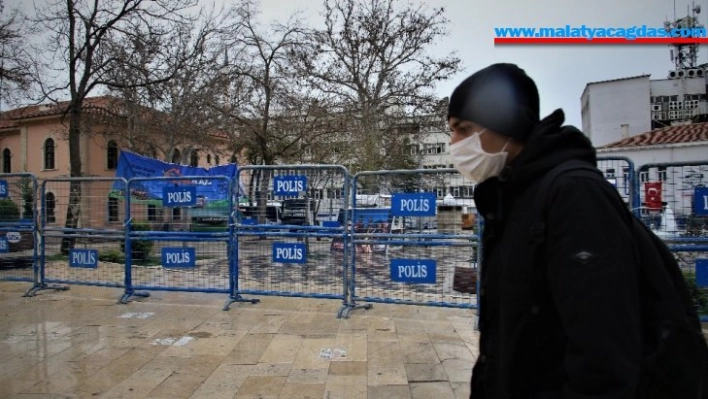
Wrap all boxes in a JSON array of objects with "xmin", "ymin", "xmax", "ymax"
[{"xmin": 448, "ymin": 64, "xmax": 708, "ymax": 399}]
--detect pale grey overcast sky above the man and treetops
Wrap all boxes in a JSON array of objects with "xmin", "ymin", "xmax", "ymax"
[{"xmin": 5, "ymin": 0, "xmax": 708, "ymax": 128}]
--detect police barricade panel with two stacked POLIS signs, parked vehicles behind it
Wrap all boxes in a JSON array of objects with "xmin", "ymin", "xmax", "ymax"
[{"xmin": 231, "ymin": 165, "xmax": 349, "ymax": 314}]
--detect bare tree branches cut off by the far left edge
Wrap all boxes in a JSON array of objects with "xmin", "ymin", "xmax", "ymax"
[{"xmin": 0, "ymin": 0, "xmax": 31, "ymax": 111}]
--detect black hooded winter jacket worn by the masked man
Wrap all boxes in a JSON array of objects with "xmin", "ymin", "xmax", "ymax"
[{"xmin": 471, "ymin": 110, "xmax": 708, "ymax": 399}]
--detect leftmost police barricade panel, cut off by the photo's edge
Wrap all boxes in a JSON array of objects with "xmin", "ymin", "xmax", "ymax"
[{"xmin": 0, "ymin": 173, "xmax": 38, "ymax": 283}]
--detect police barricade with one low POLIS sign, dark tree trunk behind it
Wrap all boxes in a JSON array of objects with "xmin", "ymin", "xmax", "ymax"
[{"xmin": 24, "ymin": 177, "xmax": 125, "ymax": 296}]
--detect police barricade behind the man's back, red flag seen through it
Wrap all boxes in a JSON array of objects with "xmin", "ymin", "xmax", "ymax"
[{"xmin": 637, "ymin": 162, "xmax": 708, "ymax": 322}]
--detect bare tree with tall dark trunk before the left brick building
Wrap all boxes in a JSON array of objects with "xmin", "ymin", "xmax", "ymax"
[{"xmin": 27, "ymin": 0, "xmax": 209, "ymax": 253}]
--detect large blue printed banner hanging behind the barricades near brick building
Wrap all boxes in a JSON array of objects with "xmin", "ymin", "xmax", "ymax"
[{"xmin": 113, "ymin": 150, "xmax": 245, "ymax": 202}]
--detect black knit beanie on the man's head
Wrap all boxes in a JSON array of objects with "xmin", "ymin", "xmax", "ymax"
[{"xmin": 448, "ymin": 64, "xmax": 540, "ymax": 142}]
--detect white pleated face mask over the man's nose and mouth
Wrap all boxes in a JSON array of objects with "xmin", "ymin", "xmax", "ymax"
[{"xmin": 450, "ymin": 129, "xmax": 509, "ymax": 183}]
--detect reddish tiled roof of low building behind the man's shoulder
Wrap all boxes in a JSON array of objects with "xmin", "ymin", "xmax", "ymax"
[{"xmin": 598, "ymin": 122, "xmax": 708, "ymax": 150}]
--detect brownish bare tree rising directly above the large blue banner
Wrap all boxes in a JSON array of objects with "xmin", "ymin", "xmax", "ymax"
[{"xmin": 101, "ymin": 4, "xmax": 228, "ymax": 163}]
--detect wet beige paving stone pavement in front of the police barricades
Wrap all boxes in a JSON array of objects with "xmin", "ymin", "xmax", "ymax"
[{"xmin": 0, "ymin": 281, "xmax": 479, "ymax": 399}]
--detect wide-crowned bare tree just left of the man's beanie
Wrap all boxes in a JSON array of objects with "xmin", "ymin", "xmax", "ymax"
[{"xmin": 298, "ymin": 0, "xmax": 460, "ymax": 169}]
